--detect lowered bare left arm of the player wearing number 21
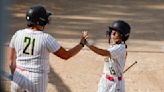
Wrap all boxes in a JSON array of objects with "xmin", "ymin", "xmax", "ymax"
[{"xmin": 9, "ymin": 48, "xmax": 16, "ymax": 74}]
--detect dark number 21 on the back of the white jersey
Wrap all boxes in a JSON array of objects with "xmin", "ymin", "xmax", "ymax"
[{"xmin": 23, "ymin": 37, "xmax": 35, "ymax": 55}]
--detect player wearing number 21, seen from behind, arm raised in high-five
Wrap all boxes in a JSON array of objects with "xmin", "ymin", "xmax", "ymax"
[{"xmin": 9, "ymin": 5, "xmax": 85, "ymax": 92}]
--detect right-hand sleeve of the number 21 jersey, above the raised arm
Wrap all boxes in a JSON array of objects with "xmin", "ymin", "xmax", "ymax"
[{"xmin": 46, "ymin": 35, "xmax": 61, "ymax": 53}]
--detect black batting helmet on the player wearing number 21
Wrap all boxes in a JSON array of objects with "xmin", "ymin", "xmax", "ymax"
[{"xmin": 26, "ymin": 5, "xmax": 52, "ymax": 26}]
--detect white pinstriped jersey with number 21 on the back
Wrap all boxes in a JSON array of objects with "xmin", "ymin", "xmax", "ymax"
[{"xmin": 10, "ymin": 28, "xmax": 60, "ymax": 72}]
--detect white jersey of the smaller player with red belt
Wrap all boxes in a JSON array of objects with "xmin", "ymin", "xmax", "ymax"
[{"xmin": 104, "ymin": 44, "xmax": 126, "ymax": 77}]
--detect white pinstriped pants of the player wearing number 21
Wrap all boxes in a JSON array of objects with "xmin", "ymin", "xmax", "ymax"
[{"xmin": 11, "ymin": 69, "xmax": 48, "ymax": 92}]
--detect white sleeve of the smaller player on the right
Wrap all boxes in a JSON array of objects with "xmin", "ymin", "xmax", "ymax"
[{"xmin": 108, "ymin": 45, "xmax": 125, "ymax": 59}]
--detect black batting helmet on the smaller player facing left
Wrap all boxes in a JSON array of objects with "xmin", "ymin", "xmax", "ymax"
[{"xmin": 108, "ymin": 20, "xmax": 131, "ymax": 41}]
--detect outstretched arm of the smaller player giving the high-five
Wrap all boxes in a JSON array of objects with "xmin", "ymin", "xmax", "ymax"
[{"xmin": 86, "ymin": 43, "xmax": 111, "ymax": 57}]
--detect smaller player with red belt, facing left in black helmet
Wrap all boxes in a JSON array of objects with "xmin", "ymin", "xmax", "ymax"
[{"xmin": 86, "ymin": 20, "xmax": 131, "ymax": 92}]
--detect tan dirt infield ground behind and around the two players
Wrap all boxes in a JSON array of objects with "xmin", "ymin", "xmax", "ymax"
[{"xmin": 2, "ymin": 0, "xmax": 164, "ymax": 92}]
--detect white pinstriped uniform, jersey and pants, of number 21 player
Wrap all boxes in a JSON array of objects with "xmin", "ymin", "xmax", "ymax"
[{"xmin": 10, "ymin": 29, "xmax": 60, "ymax": 92}]
